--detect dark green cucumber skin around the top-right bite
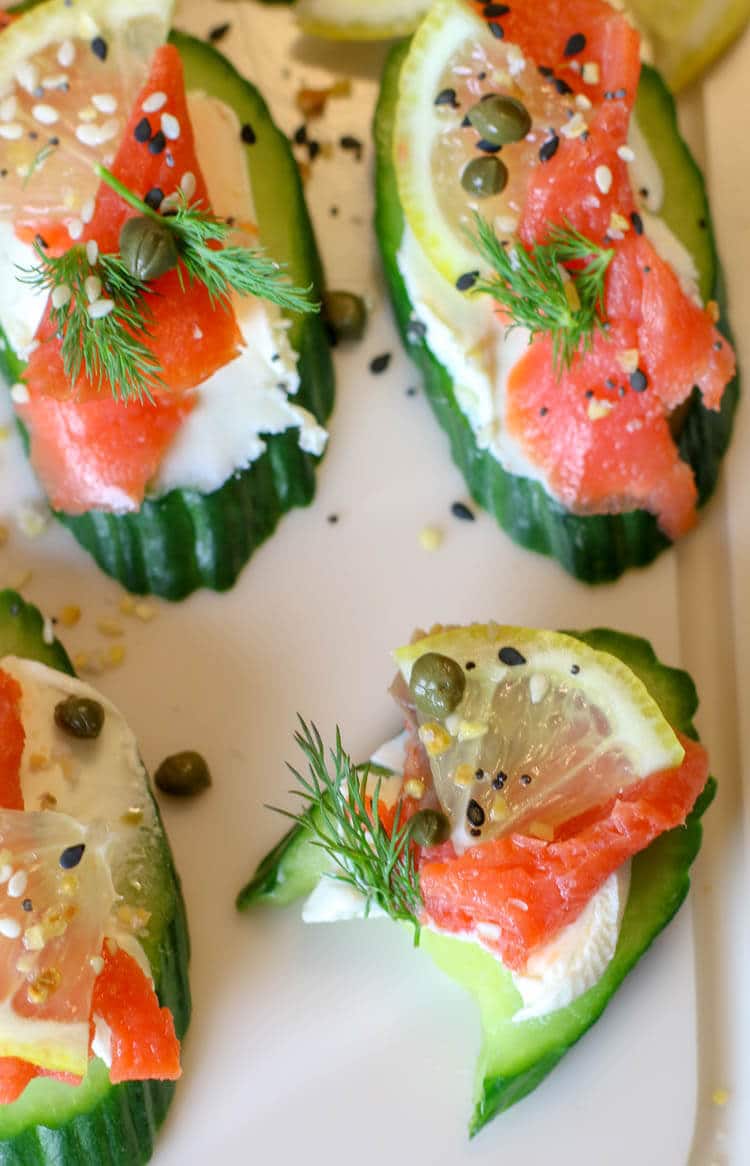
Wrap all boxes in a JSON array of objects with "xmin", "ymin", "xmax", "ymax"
[{"xmin": 374, "ymin": 42, "xmax": 740, "ymax": 583}]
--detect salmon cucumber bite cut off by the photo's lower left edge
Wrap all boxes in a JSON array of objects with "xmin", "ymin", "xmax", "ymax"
[{"xmin": 0, "ymin": 591, "xmax": 190, "ymax": 1166}]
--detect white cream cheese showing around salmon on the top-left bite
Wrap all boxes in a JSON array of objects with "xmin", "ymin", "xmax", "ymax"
[{"xmin": 0, "ymin": 93, "xmax": 328, "ymax": 496}]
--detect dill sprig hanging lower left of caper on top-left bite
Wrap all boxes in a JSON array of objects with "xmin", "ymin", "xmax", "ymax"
[{"xmin": 17, "ymin": 241, "xmax": 163, "ymax": 401}]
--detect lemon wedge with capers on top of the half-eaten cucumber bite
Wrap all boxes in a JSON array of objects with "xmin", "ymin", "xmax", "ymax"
[{"xmin": 394, "ymin": 624, "xmax": 685, "ymax": 845}]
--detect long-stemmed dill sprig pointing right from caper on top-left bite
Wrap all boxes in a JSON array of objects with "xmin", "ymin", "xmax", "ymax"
[{"xmin": 96, "ymin": 166, "xmax": 320, "ymax": 312}]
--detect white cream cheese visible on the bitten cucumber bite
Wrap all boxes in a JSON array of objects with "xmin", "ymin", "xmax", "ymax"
[{"xmin": 302, "ymin": 733, "xmax": 630, "ymax": 1023}]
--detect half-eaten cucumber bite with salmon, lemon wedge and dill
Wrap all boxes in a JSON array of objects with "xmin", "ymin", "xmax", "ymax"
[{"xmin": 238, "ymin": 624, "xmax": 714, "ymax": 1135}]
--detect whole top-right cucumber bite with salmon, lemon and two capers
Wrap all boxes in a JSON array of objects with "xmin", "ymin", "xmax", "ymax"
[{"xmin": 376, "ymin": 0, "xmax": 738, "ymax": 582}]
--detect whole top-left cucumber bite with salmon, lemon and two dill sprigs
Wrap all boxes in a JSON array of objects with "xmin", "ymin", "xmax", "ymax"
[{"xmin": 0, "ymin": 0, "xmax": 334, "ymax": 599}]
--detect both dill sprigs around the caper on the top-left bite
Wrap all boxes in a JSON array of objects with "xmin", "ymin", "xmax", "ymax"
[{"xmin": 17, "ymin": 166, "xmax": 318, "ymax": 402}]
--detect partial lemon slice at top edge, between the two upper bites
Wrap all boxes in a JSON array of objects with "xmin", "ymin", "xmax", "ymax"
[{"xmin": 296, "ymin": 0, "xmax": 430, "ymax": 41}]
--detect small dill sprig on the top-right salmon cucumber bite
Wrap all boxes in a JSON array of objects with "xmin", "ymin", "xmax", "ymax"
[{"xmin": 474, "ymin": 215, "xmax": 615, "ymax": 379}]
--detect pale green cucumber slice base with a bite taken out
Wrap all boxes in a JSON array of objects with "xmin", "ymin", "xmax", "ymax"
[{"xmin": 237, "ymin": 628, "xmax": 715, "ymax": 1135}]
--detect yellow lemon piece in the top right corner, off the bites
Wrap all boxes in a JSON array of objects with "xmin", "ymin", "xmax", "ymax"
[{"xmin": 629, "ymin": 0, "xmax": 750, "ymax": 90}]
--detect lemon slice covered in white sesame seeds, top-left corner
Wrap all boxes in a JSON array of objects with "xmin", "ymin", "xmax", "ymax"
[{"xmin": 0, "ymin": 0, "xmax": 174, "ymax": 225}]
